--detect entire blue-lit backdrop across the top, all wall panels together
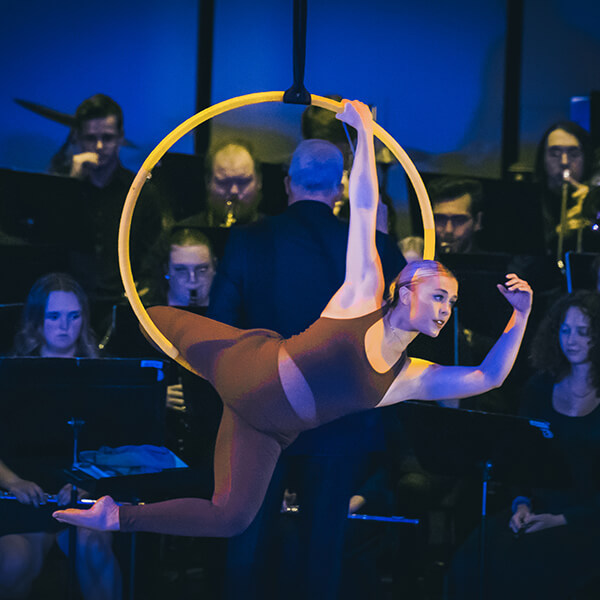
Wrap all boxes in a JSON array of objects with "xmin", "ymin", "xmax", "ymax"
[{"xmin": 0, "ymin": 0, "xmax": 600, "ymax": 182}]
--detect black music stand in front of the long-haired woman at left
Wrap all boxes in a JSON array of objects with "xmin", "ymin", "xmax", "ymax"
[{"xmin": 0, "ymin": 358, "xmax": 167, "ymax": 598}]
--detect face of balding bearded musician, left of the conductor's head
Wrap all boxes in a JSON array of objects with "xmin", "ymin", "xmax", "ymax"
[{"xmin": 208, "ymin": 144, "xmax": 260, "ymax": 223}]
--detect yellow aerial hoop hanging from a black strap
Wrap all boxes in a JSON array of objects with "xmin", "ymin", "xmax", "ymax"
[{"xmin": 119, "ymin": 92, "xmax": 435, "ymax": 372}]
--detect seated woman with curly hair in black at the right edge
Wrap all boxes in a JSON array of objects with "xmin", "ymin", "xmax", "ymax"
[{"xmin": 449, "ymin": 291, "xmax": 600, "ymax": 600}]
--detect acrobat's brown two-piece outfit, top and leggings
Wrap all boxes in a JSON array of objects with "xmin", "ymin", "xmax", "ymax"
[{"xmin": 119, "ymin": 307, "xmax": 406, "ymax": 536}]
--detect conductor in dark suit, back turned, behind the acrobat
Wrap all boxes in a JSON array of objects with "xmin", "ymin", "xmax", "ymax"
[{"xmin": 208, "ymin": 140, "xmax": 405, "ymax": 600}]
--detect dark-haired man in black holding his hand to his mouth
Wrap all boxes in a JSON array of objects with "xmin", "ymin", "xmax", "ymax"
[{"xmin": 51, "ymin": 94, "xmax": 172, "ymax": 298}]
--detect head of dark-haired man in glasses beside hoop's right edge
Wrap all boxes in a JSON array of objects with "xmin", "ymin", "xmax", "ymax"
[{"xmin": 429, "ymin": 177, "xmax": 483, "ymax": 255}]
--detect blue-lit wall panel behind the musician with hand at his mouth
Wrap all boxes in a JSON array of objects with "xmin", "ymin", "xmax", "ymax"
[{"xmin": 0, "ymin": 0, "xmax": 197, "ymax": 171}]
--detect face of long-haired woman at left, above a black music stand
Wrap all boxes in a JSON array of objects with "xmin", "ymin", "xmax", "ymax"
[{"xmin": 42, "ymin": 291, "xmax": 82, "ymax": 356}]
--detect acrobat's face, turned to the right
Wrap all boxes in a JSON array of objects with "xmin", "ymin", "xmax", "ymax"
[{"xmin": 409, "ymin": 275, "xmax": 458, "ymax": 337}]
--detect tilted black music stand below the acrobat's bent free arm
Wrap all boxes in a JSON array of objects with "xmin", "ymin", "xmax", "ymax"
[{"xmin": 399, "ymin": 401, "xmax": 568, "ymax": 599}]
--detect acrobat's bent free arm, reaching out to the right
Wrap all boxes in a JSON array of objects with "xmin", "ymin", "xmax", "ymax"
[{"xmin": 381, "ymin": 273, "xmax": 532, "ymax": 405}]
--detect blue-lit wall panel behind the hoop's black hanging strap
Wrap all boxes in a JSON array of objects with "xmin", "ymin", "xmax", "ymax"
[{"xmin": 213, "ymin": 0, "xmax": 506, "ymax": 175}]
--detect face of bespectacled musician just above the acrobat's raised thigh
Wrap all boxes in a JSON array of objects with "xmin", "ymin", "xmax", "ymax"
[{"xmin": 168, "ymin": 244, "xmax": 215, "ymax": 306}]
